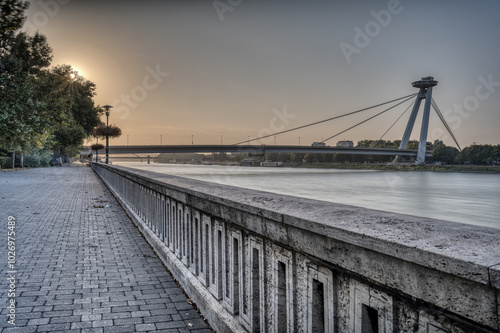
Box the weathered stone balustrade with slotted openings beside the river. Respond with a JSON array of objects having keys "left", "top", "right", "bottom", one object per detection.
[{"left": 93, "top": 164, "right": 500, "bottom": 333}]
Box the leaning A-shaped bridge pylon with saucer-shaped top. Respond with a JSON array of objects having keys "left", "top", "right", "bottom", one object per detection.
[{"left": 396, "top": 76, "right": 438, "bottom": 164}]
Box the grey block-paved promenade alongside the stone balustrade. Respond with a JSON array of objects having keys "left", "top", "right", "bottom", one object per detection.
[{"left": 0, "top": 164, "right": 211, "bottom": 333}]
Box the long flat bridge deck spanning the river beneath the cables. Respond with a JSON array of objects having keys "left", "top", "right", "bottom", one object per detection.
[{"left": 82, "top": 145, "right": 432, "bottom": 158}]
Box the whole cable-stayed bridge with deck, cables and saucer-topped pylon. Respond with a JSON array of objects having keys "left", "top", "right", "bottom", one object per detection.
[{"left": 82, "top": 76, "right": 460, "bottom": 164}]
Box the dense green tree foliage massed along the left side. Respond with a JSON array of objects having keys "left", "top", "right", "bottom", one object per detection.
[{"left": 0, "top": 0, "right": 106, "bottom": 165}]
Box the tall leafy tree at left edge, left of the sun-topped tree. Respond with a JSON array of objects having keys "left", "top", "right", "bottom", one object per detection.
[{"left": 0, "top": 33, "right": 58, "bottom": 164}]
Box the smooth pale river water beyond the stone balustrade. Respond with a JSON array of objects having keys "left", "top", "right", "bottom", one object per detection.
[{"left": 114, "top": 163, "right": 500, "bottom": 229}]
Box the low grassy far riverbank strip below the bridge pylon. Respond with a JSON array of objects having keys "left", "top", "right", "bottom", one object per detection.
[{"left": 285, "top": 163, "right": 500, "bottom": 173}]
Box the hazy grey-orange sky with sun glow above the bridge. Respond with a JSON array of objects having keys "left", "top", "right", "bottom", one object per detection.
[{"left": 25, "top": 0, "right": 500, "bottom": 146}]
